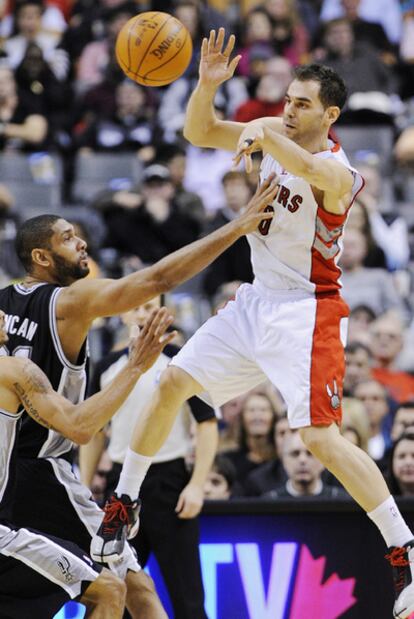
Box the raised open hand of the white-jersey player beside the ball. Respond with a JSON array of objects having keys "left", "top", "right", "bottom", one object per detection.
[{"left": 200, "top": 28, "right": 241, "bottom": 88}]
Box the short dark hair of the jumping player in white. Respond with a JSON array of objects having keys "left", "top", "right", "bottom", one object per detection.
[{"left": 293, "top": 64, "right": 348, "bottom": 110}]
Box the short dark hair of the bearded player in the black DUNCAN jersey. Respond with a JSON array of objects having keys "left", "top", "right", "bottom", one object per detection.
[{"left": 15, "top": 215, "right": 62, "bottom": 273}]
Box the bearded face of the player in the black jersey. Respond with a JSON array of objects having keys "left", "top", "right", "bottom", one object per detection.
[{"left": 50, "top": 219, "right": 89, "bottom": 286}]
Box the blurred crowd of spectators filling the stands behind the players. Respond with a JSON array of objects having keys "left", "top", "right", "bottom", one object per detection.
[{"left": 0, "top": 0, "right": 414, "bottom": 501}]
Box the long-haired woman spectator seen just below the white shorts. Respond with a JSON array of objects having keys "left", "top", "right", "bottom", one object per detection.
[{"left": 224, "top": 393, "right": 275, "bottom": 485}]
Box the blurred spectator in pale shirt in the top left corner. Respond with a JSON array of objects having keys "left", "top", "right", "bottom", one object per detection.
[{"left": 4, "top": 0, "right": 69, "bottom": 81}]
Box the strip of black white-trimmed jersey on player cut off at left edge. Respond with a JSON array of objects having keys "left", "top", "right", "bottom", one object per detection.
[{"left": 0, "top": 408, "right": 23, "bottom": 521}]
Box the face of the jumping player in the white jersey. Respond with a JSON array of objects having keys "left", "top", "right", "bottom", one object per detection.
[{"left": 283, "top": 80, "right": 330, "bottom": 143}]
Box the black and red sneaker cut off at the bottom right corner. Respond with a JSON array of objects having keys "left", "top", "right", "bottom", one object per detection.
[{"left": 385, "top": 539, "right": 414, "bottom": 619}]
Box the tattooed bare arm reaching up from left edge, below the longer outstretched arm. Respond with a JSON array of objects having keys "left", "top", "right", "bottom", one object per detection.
[{"left": 0, "top": 308, "right": 176, "bottom": 444}]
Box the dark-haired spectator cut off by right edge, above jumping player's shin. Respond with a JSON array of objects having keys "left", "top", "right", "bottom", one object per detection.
[{"left": 388, "top": 432, "right": 414, "bottom": 497}]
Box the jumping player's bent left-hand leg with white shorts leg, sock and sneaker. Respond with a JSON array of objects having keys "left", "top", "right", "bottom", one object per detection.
[{"left": 91, "top": 290, "right": 265, "bottom": 562}]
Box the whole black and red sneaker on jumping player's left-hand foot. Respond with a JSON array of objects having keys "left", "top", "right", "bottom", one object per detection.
[{"left": 91, "top": 493, "right": 141, "bottom": 563}]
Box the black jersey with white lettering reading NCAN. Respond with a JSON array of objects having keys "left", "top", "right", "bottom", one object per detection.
[{"left": 0, "top": 283, "right": 87, "bottom": 458}]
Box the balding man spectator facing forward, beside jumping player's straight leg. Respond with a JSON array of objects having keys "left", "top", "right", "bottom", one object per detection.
[{"left": 263, "top": 431, "right": 348, "bottom": 499}]
